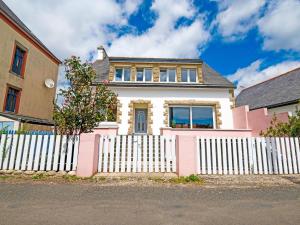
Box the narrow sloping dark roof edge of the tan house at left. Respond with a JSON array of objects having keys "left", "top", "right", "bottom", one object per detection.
[{"left": 0, "top": 0, "right": 61, "bottom": 63}]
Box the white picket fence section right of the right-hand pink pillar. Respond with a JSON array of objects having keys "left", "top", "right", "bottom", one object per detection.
[{"left": 197, "top": 137, "right": 300, "bottom": 174}]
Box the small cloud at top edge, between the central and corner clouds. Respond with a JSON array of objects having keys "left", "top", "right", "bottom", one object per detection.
[{"left": 215, "top": 0, "right": 265, "bottom": 40}]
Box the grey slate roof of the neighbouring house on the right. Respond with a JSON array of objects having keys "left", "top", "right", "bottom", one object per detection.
[{"left": 236, "top": 67, "right": 300, "bottom": 109}]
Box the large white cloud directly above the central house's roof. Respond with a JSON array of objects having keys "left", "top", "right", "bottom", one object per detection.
[{"left": 108, "top": 0, "right": 210, "bottom": 57}]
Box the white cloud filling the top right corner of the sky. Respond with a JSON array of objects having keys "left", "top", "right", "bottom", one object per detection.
[{"left": 258, "top": 0, "right": 300, "bottom": 51}]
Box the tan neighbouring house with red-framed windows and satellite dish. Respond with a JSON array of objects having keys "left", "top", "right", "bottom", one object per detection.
[{"left": 0, "top": 0, "right": 61, "bottom": 130}]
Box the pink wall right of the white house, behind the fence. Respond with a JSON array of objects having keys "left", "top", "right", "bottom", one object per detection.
[{"left": 233, "top": 106, "right": 289, "bottom": 136}]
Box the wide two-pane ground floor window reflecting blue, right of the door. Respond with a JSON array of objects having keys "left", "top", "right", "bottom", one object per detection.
[{"left": 169, "top": 106, "right": 214, "bottom": 128}]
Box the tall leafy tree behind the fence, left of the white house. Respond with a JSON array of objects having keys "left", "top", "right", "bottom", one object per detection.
[{"left": 53, "top": 56, "right": 117, "bottom": 135}]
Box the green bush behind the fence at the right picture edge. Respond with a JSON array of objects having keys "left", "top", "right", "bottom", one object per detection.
[{"left": 261, "top": 110, "right": 300, "bottom": 137}]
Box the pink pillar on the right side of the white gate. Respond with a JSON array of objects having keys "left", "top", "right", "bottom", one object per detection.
[{"left": 176, "top": 135, "right": 197, "bottom": 176}]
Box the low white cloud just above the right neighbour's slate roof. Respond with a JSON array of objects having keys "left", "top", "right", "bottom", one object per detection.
[{"left": 227, "top": 60, "right": 300, "bottom": 92}]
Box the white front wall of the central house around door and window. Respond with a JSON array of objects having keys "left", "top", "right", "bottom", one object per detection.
[{"left": 111, "top": 87, "right": 233, "bottom": 135}]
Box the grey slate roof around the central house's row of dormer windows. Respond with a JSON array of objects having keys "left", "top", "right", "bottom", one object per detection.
[{"left": 93, "top": 56, "right": 234, "bottom": 88}]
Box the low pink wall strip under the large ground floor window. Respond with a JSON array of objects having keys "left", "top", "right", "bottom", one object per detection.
[{"left": 161, "top": 128, "right": 252, "bottom": 137}]
